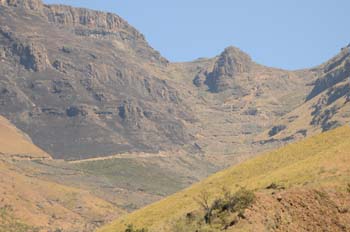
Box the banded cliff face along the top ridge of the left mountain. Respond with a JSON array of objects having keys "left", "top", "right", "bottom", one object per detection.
[{"left": 44, "top": 5, "right": 168, "bottom": 64}]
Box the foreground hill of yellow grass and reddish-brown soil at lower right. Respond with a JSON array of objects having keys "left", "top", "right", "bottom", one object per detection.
[{"left": 98, "top": 126, "right": 350, "bottom": 232}]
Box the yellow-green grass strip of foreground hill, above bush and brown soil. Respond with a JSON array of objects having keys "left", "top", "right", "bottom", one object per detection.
[{"left": 99, "top": 126, "right": 350, "bottom": 232}]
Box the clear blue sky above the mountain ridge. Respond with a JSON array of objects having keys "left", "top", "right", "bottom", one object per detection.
[{"left": 44, "top": 0, "right": 350, "bottom": 69}]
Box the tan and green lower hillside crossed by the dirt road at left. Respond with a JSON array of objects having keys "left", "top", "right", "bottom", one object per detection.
[{"left": 0, "top": 113, "right": 216, "bottom": 232}]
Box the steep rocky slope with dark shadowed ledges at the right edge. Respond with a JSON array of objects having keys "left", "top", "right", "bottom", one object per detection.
[{"left": 260, "top": 46, "right": 350, "bottom": 145}]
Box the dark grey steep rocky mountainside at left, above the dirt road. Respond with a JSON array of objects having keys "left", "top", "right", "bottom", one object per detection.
[{"left": 0, "top": 0, "right": 193, "bottom": 159}]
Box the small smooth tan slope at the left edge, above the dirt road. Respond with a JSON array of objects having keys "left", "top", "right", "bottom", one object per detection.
[{"left": 0, "top": 116, "right": 50, "bottom": 158}]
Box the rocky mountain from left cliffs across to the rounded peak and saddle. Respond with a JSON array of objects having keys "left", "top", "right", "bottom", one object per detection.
[{"left": 0, "top": 0, "right": 316, "bottom": 163}]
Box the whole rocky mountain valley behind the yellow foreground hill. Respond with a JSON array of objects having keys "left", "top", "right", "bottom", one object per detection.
[{"left": 0, "top": 0, "right": 350, "bottom": 232}]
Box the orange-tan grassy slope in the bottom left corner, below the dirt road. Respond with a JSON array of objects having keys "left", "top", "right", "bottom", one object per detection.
[{"left": 0, "top": 160, "right": 123, "bottom": 232}]
